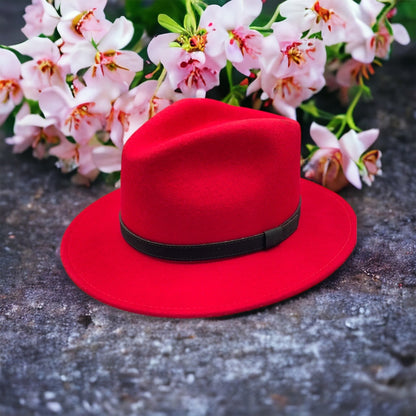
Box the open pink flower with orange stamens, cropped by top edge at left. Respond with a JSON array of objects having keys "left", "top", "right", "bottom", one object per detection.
[{"left": 58, "top": 0, "right": 111, "bottom": 44}]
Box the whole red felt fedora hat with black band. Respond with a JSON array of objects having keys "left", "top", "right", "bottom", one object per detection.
[{"left": 61, "top": 99, "right": 356, "bottom": 318}]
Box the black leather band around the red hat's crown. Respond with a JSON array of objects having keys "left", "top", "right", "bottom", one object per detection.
[{"left": 120, "top": 202, "right": 301, "bottom": 261}]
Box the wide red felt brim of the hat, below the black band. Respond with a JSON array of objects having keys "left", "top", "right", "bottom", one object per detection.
[{"left": 61, "top": 179, "right": 357, "bottom": 318}]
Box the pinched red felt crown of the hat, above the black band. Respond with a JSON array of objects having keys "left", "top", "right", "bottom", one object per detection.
[{"left": 121, "top": 99, "right": 300, "bottom": 244}]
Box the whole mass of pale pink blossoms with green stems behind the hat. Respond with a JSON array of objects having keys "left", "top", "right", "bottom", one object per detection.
[{"left": 0, "top": 0, "right": 410, "bottom": 190}]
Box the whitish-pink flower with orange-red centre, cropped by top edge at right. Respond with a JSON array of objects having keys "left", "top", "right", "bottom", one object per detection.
[{"left": 280, "top": 0, "right": 358, "bottom": 45}]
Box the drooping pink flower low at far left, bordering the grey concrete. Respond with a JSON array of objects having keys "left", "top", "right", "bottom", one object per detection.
[{"left": 6, "top": 103, "right": 64, "bottom": 159}]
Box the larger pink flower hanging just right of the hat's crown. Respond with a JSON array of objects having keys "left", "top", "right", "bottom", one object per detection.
[{"left": 304, "top": 123, "right": 379, "bottom": 189}]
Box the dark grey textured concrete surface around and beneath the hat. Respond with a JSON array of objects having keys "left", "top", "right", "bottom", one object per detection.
[{"left": 0, "top": 0, "right": 416, "bottom": 416}]
